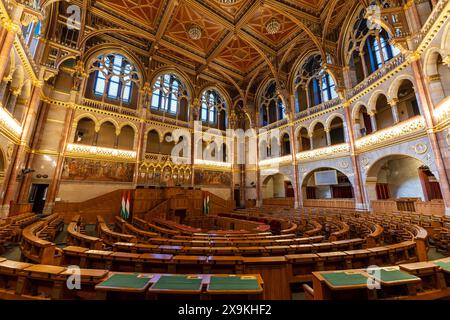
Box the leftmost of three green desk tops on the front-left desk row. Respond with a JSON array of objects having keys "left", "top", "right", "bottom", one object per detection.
[{"left": 95, "top": 273, "right": 153, "bottom": 293}]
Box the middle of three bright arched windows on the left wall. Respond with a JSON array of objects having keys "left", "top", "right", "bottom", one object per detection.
[{"left": 151, "top": 74, "right": 187, "bottom": 115}]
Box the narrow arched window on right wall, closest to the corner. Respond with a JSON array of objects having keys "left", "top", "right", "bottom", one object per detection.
[{"left": 260, "top": 80, "right": 286, "bottom": 126}]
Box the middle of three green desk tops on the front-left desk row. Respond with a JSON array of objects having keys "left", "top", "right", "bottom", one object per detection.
[{"left": 149, "top": 275, "right": 205, "bottom": 293}]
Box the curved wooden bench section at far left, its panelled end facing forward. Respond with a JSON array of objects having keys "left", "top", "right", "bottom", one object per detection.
[{"left": 20, "top": 214, "right": 62, "bottom": 265}]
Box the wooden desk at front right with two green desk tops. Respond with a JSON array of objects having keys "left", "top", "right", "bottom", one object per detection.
[{"left": 303, "top": 258, "right": 450, "bottom": 300}]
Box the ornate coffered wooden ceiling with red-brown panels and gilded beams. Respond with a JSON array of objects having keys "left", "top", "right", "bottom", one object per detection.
[{"left": 50, "top": 0, "right": 367, "bottom": 94}]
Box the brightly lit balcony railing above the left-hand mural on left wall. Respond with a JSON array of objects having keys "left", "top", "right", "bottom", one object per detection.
[{"left": 67, "top": 143, "right": 136, "bottom": 160}]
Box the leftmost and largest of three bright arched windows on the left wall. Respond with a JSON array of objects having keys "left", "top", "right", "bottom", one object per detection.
[{"left": 94, "top": 54, "right": 137, "bottom": 103}]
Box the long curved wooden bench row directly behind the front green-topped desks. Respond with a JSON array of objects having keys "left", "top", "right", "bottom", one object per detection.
[{"left": 62, "top": 241, "right": 417, "bottom": 299}]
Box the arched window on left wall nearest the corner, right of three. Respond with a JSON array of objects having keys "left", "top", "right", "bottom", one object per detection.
[{"left": 200, "top": 89, "right": 228, "bottom": 130}]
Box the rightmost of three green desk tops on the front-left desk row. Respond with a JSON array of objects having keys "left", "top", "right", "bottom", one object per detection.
[{"left": 206, "top": 275, "right": 263, "bottom": 294}]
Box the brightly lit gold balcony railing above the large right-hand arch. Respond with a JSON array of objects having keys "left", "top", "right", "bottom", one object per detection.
[{"left": 355, "top": 116, "right": 425, "bottom": 149}]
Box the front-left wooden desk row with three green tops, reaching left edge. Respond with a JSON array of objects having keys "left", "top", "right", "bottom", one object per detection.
[{"left": 0, "top": 258, "right": 264, "bottom": 300}]
